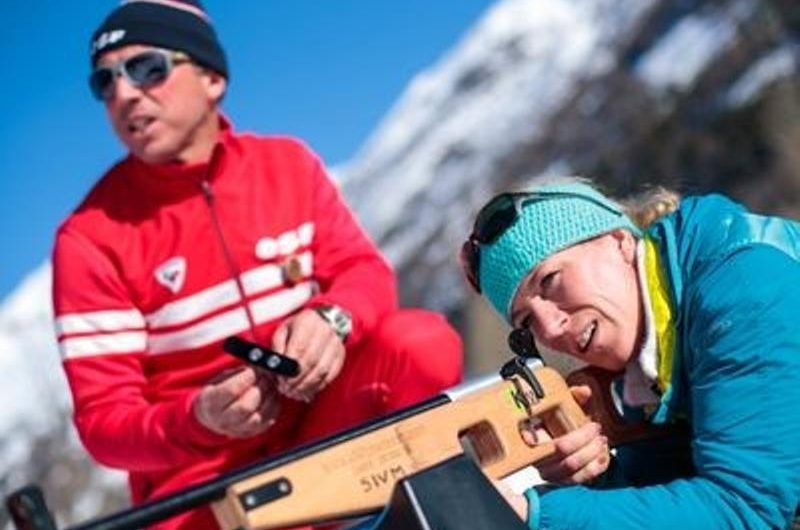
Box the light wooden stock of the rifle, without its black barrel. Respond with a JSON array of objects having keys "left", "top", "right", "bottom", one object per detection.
[{"left": 212, "top": 368, "right": 589, "bottom": 530}]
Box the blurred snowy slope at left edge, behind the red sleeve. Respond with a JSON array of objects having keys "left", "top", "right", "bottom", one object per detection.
[{"left": 0, "top": 263, "right": 125, "bottom": 527}]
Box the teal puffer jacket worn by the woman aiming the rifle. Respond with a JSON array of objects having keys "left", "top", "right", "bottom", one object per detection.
[{"left": 527, "top": 195, "right": 800, "bottom": 530}]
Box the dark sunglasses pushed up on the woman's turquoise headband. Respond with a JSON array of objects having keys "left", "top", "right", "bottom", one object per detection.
[{"left": 459, "top": 191, "right": 623, "bottom": 294}]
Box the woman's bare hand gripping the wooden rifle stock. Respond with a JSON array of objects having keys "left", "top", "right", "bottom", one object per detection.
[{"left": 522, "top": 386, "right": 610, "bottom": 484}]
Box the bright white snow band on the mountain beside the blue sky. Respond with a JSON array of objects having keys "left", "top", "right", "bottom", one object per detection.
[{"left": 342, "top": 0, "right": 654, "bottom": 239}]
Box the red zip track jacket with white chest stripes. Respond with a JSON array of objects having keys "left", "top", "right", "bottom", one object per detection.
[{"left": 53, "top": 118, "right": 397, "bottom": 508}]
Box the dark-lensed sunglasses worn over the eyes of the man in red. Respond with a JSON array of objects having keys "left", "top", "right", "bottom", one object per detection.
[{"left": 89, "top": 49, "right": 191, "bottom": 101}]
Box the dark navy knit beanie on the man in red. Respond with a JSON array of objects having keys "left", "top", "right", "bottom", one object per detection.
[{"left": 91, "top": 0, "right": 228, "bottom": 78}]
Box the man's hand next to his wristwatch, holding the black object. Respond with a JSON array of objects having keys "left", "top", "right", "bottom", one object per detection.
[{"left": 272, "top": 309, "right": 345, "bottom": 401}]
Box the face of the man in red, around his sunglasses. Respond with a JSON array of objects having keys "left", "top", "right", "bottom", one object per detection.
[{"left": 97, "top": 45, "right": 225, "bottom": 164}]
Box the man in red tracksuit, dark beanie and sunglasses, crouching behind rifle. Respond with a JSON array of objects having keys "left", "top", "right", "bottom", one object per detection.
[{"left": 53, "top": 0, "right": 462, "bottom": 529}]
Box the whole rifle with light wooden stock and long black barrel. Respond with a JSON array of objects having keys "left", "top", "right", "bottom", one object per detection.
[{"left": 7, "top": 358, "right": 664, "bottom": 530}]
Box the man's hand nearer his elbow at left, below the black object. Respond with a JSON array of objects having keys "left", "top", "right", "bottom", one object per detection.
[{"left": 192, "top": 367, "right": 280, "bottom": 438}]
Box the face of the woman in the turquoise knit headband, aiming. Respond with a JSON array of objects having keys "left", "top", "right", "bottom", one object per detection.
[{"left": 511, "top": 230, "right": 642, "bottom": 370}]
